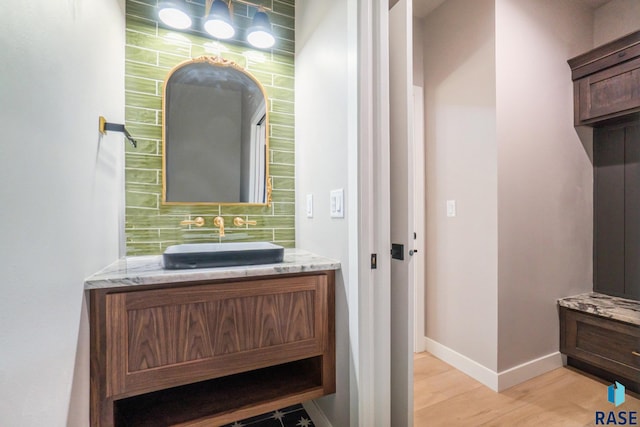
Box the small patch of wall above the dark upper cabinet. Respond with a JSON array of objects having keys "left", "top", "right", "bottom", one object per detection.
[{"left": 593, "top": 0, "right": 640, "bottom": 47}]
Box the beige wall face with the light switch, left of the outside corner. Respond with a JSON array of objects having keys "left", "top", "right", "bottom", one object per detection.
[{"left": 422, "top": 0, "right": 498, "bottom": 371}]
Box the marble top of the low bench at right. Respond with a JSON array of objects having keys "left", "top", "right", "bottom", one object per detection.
[{"left": 558, "top": 292, "right": 640, "bottom": 326}]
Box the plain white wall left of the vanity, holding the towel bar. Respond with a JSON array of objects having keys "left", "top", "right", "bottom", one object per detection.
[{"left": 0, "top": 0, "right": 124, "bottom": 427}]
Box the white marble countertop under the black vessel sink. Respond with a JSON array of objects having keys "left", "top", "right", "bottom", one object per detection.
[{"left": 84, "top": 249, "right": 340, "bottom": 289}]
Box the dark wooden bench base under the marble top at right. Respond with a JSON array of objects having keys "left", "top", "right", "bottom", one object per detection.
[{"left": 560, "top": 307, "right": 640, "bottom": 392}]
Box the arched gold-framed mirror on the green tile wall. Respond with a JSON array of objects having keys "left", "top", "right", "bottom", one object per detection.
[{"left": 163, "top": 56, "right": 268, "bottom": 204}]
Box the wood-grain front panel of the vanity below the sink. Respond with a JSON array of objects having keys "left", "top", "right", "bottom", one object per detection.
[{"left": 106, "top": 275, "right": 328, "bottom": 397}]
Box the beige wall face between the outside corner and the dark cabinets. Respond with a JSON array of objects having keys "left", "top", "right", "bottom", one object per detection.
[{"left": 496, "top": 0, "right": 593, "bottom": 371}]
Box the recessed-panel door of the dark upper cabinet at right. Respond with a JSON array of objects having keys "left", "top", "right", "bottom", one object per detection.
[{"left": 575, "top": 58, "right": 640, "bottom": 124}]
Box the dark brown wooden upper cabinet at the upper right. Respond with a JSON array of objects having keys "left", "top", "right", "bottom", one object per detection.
[{"left": 567, "top": 31, "right": 640, "bottom": 126}]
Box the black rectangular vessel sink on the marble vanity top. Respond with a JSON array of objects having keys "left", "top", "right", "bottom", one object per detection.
[{"left": 162, "top": 242, "right": 284, "bottom": 270}]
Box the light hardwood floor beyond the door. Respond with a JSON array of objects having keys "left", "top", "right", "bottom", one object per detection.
[{"left": 414, "top": 353, "right": 640, "bottom": 427}]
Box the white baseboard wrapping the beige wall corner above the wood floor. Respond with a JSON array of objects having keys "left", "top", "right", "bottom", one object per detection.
[{"left": 425, "top": 337, "right": 563, "bottom": 392}]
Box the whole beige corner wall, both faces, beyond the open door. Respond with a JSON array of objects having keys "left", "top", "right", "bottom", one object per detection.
[{"left": 422, "top": 0, "right": 593, "bottom": 373}]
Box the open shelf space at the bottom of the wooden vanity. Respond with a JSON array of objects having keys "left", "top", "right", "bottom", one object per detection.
[{"left": 114, "top": 357, "right": 325, "bottom": 427}]
